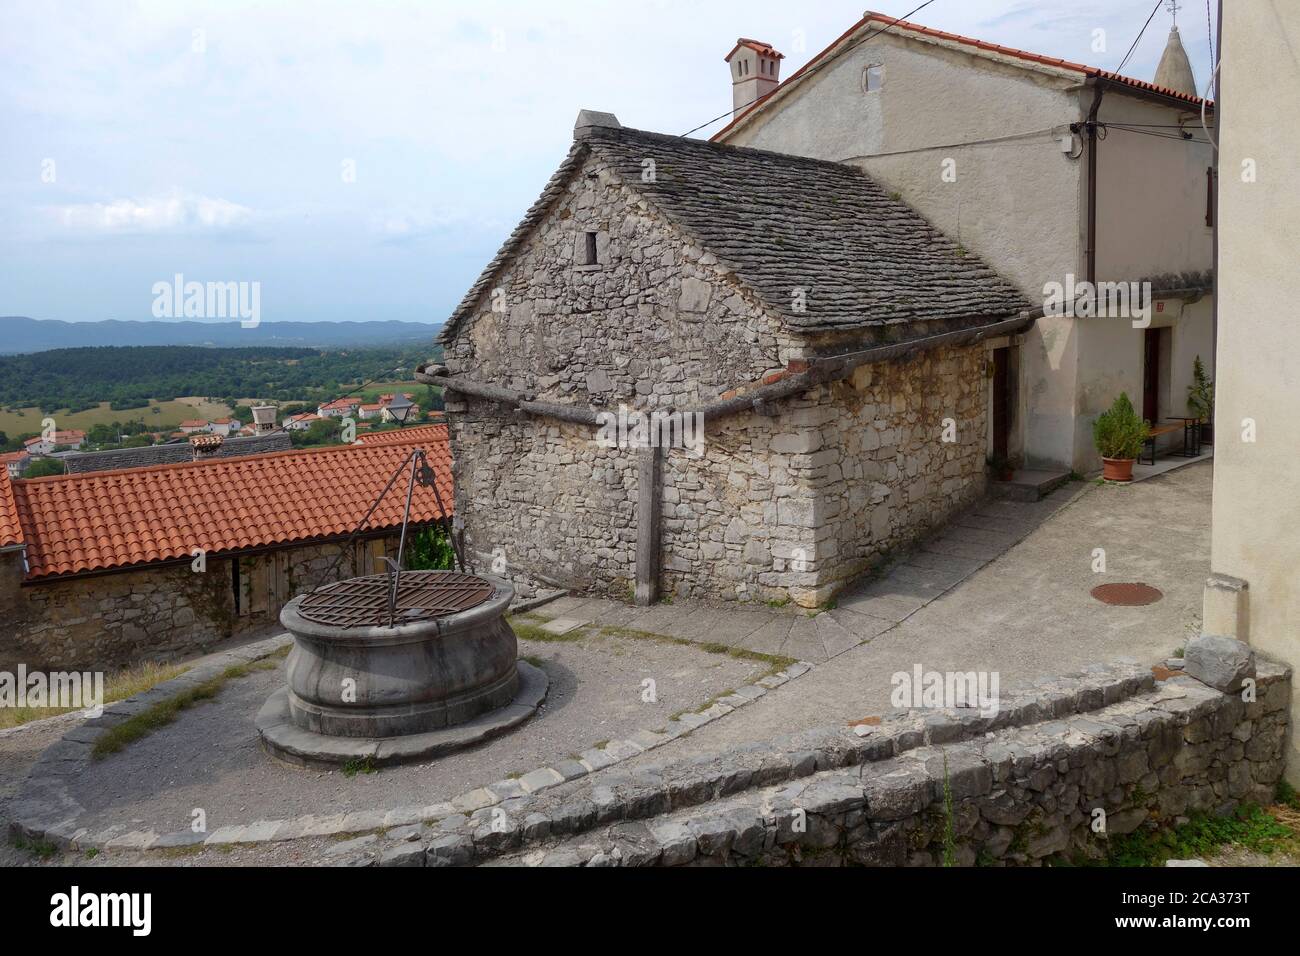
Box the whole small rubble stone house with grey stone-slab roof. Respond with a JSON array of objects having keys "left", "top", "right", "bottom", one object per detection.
[{"left": 417, "top": 112, "right": 1034, "bottom": 606}]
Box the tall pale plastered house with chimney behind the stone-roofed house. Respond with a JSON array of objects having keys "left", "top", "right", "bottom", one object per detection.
[{"left": 714, "top": 13, "right": 1216, "bottom": 473}]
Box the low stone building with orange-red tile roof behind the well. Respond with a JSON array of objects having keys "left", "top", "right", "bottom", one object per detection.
[{"left": 0, "top": 425, "right": 452, "bottom": 669}]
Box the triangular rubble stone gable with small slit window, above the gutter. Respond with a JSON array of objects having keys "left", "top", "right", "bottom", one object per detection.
[{"left": 445, "top": 149, "right": 802, "bottom": 407}]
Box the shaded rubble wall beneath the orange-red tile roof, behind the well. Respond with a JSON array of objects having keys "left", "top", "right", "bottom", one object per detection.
[{"left": 0, "top": 538, "right": 395, "bottom": 670}]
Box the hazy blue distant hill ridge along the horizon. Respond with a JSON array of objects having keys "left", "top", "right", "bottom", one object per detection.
[{"left": 0, "top": 316, "right": 442, "bottom": 355}]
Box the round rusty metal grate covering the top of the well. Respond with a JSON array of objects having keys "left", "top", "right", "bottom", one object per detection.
[{"left": 298, "top": 571, "right": 493, "bottom": 630}]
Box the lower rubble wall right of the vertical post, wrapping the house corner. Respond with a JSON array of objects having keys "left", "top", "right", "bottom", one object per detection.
[{"left": 663, "top": 346, "right": 987, "bottom": 607}]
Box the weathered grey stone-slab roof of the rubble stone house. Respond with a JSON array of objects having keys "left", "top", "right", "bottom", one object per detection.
[{"left": 441, "top": 126, "right": 1028, "bottom": 342}]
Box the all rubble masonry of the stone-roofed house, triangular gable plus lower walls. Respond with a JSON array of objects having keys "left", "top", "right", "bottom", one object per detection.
[{"left": 446, "top": 151, "right": 987, "bottom": 607}]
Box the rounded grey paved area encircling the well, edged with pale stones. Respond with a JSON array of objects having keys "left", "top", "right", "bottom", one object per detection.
[{"left": 8, "top": 629, "right": 811, "bottom": 860}]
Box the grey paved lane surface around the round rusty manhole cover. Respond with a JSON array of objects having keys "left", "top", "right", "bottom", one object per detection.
[{"left": 608, "top": 463, "right": 1213, "bottom": 769}]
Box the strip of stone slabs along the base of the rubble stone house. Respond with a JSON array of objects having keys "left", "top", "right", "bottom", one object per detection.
[{"left": 532, "top": 483, "right": 1092, "bottom": 663}]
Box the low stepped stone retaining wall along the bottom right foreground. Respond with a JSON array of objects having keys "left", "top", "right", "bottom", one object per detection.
[{"left": 366, "top": 661, "right": 1292, "bottom": 866}]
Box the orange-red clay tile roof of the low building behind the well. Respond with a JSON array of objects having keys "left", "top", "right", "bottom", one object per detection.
[{"left": 8, "top": 428, "right": 452, "bottom": 580}]
